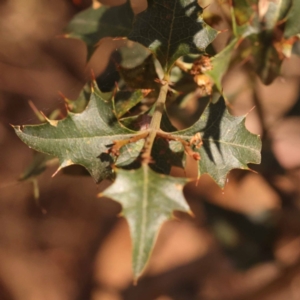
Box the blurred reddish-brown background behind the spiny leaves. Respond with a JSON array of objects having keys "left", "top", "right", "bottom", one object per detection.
[{"left": 0, "top": 0, "right": 300, "bottom": 300}]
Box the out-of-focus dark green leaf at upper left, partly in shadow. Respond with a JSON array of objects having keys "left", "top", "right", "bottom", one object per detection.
[{"left": 66, "top": 1, "right": 134, "bottom": 59}]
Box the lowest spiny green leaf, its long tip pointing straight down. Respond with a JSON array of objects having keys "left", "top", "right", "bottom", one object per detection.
[{"left": 102, "top": 165, "right": 189, "bottom": 279}]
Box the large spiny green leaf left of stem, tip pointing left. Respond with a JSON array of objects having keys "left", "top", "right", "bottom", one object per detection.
[{"left": 15, "top": 86, "right": 142, "bottom": 182}]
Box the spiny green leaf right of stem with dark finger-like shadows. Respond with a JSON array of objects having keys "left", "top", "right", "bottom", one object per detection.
[{"left": 173, "top": 98, "right": 261, "bottom": 187}]
